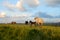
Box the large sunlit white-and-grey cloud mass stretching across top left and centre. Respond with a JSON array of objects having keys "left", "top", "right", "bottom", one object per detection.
[{"left": 3, "top": 0, "right": 39, "bottom": 11}]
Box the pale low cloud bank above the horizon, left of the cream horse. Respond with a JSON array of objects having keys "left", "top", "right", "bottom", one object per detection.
[{"left": 0, "top": 13, "right": 33, "bottom": 23}]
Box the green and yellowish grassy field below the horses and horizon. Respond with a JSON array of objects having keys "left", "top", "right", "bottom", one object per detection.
[{"left": 0, "top": 24, "right": 60, "bottom": 40}]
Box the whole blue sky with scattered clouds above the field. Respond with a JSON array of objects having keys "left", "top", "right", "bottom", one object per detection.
[{"left": 0, "top": 0, "right": 60, "bottom": 23}]
